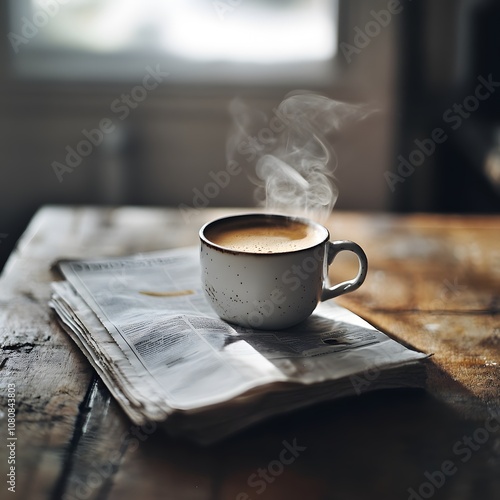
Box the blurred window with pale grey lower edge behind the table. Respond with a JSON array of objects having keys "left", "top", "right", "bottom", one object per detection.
[{"left": 9, "top": 0, "right": 337, "bottom": 83}]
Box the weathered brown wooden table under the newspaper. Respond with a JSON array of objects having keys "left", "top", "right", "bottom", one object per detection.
[{"left": 0, "top": 207, "right": 500, "bottom": 500}]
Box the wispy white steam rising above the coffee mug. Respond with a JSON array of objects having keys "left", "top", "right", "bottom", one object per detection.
[{"left": 227, "top": 91, "right": 373, "bottom": 220}]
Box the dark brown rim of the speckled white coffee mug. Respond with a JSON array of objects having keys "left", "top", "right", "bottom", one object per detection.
[{"left": 198, "top": 212, "right": 330, "bottom": 257}]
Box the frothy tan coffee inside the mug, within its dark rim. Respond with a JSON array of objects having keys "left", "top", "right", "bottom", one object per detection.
[{"left": 207, "top": 219, "right": 325, "bottom": 253}]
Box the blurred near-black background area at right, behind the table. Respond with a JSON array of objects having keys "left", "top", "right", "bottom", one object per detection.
[{"left": 393, "top": 1, "right": 500, "bottom": 213}]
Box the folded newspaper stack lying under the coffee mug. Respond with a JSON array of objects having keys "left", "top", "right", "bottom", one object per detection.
[{"left": 50, "top": 248, "right": 427, "bottom": 444}]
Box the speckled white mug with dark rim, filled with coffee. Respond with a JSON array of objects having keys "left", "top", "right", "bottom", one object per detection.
[{"left": 199, "top": 213, "right": 368, "bottom": 330}]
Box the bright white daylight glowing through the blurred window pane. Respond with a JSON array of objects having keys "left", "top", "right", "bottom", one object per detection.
[{"left": 31, "top": 0, "right": 337, "bottom": 64}]
